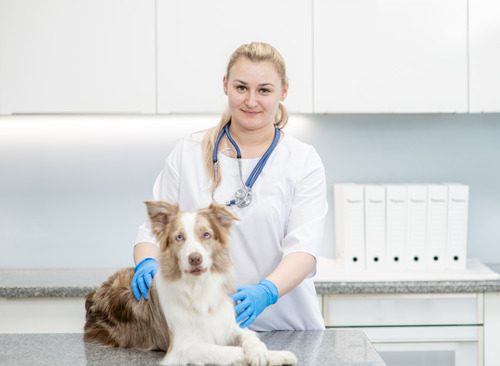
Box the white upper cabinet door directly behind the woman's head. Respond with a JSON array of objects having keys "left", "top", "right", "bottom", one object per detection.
[{"left": 157, "top": 0, "right": 312, "bottom": 113}]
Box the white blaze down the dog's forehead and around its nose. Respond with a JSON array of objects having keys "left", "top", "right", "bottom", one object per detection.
[{"left": 179, "top": 212, "right": 212, "bottom": 270}]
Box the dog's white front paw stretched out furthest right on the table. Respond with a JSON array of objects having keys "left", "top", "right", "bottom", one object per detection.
[{"left": 236, "top": 329, "right": 297, "bottom": 366}]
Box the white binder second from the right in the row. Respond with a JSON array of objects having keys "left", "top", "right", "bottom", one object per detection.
[{"left": 426, "top": 184, "right": 448, "bottom": 270}]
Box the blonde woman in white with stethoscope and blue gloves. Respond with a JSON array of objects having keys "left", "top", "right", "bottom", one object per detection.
[{"left": 132, "top": 43, "right": 327, "bottom": 331}]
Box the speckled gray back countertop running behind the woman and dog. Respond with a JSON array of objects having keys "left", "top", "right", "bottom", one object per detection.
[{"left": 0, "top": 264, "right": 500, "bottom": 298}]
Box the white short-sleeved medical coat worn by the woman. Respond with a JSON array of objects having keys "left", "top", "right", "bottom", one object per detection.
[{"left": 136, "top": 129, "right": 328, "bottom": 331}]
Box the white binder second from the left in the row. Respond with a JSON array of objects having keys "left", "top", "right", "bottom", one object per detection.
[{"left": 365, "top": 185, "right": 387, "bottom": 271}]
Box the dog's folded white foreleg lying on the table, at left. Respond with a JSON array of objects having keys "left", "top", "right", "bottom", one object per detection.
[{"left": 160, "top": 343, "right": 246, "bottom": 366}]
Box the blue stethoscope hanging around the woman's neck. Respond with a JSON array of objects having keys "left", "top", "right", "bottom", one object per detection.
[{"left": 212, "top": 121, "right": 280, "bottom": 208}]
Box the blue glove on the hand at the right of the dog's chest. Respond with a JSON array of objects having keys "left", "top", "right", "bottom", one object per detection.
[{"left": 231, "top": 280, "right": 278, "bottom": 328}]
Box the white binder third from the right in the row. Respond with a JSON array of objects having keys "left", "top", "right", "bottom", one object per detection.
[{"left": 406, "top": 184, "right": 427, "bottom": 271}]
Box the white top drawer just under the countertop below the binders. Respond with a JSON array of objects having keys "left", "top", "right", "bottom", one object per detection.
[{"left": 322, "top": 294, "right": 483, "bottom": 327}]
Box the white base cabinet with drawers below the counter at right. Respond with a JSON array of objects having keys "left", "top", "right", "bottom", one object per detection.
[{"left": 322, "top": 293, "right": 482, "bottom": 366}]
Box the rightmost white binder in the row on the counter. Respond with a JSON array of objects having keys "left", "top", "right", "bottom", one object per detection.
[{"left": 446, "top": 184, "right": 469, "bottom": 270}]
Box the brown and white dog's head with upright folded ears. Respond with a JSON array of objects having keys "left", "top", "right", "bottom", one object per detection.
[{"left": 145, "top": 201, "right": 237, "bottom": 280}]
